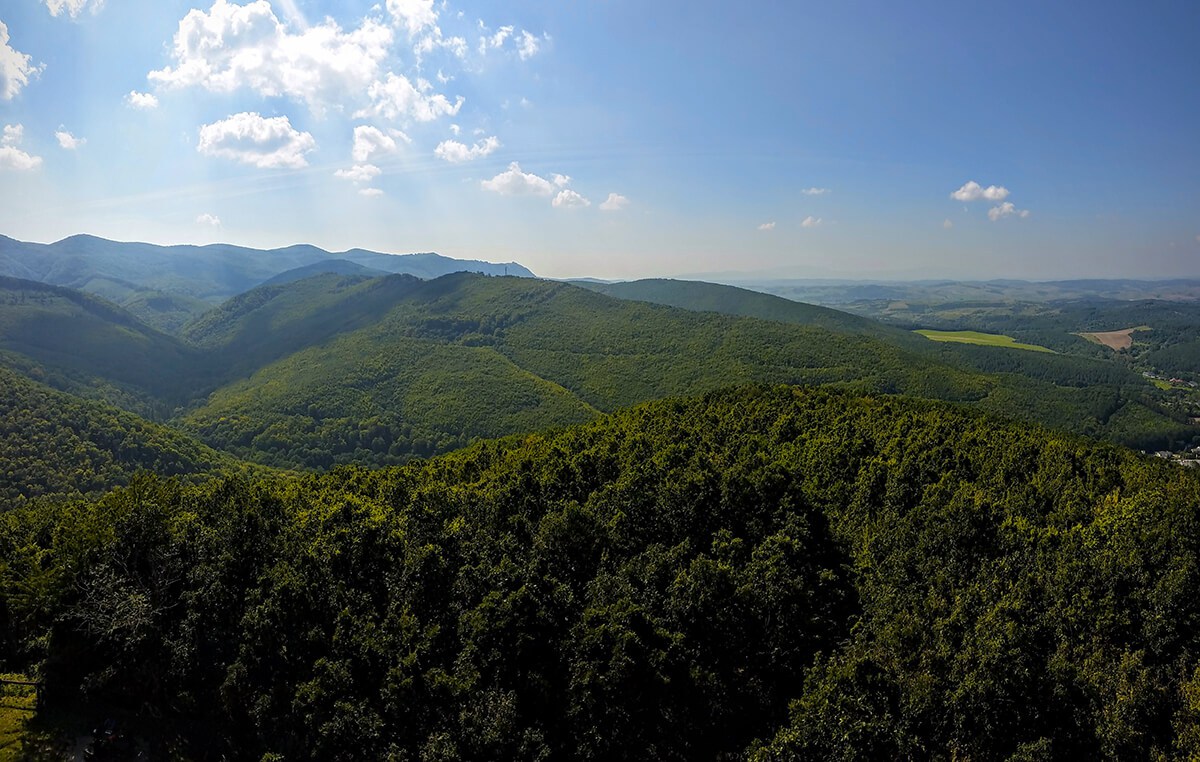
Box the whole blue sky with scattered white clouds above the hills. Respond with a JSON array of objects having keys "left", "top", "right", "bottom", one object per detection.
[{"left": 0, "top": 0, "right": 1200, "bottom": 280}]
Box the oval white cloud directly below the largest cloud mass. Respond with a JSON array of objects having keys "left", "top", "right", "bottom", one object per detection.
[{"left": 196, "top": 112, "right": 317, "bottom": 169}]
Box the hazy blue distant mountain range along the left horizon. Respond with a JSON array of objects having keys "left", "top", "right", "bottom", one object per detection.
[{"left": 0, "top": 235, "right": 534, "bottom": 329}]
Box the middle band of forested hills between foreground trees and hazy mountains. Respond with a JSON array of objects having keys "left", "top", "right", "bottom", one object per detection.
[{"left": 0, "top": 268, "right": 1196, "bottom": 468}]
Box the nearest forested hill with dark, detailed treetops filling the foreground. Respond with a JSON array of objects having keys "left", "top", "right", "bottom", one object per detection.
[{"left": 0, "top": 388, "right": 1200, "bottom": 761}]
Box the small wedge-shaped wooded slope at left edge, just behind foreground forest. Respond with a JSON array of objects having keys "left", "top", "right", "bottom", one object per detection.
[{"left": 0, "top": 367, "right": 235, "bottom": 504}]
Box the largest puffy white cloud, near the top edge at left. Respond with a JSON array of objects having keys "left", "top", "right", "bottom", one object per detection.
[{"left": 149, "top": 0, "right": 392, "bottom": 112}]
